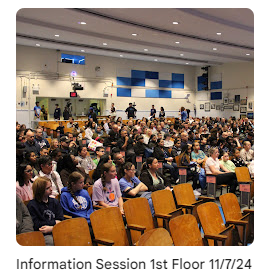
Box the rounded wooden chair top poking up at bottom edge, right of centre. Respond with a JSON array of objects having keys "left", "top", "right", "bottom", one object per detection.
[{"left": 137, "top": 228, "right": 173, "bottom": 246}]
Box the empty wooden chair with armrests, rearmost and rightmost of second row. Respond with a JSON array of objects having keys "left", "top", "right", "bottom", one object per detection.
[{"left": 173, "top": 183, "right": 215, "bottom": 223}]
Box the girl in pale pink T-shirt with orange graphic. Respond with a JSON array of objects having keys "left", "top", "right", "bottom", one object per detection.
[{"left": 92, "top": 162, "right": 124, "bottom": 215}]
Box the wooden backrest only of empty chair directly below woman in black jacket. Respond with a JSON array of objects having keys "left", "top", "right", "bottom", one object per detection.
[{"left": 151, "top": 190, "right": 176, "bottom": 227}]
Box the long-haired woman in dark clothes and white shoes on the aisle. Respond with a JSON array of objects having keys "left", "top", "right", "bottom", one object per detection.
[{"left": 179, "top": 144, "right": 201, "bottom": 196}]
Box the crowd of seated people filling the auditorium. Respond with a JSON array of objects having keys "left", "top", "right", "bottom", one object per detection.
[{"left": 16, "top": 117, "right": 254, "bottom": 245}]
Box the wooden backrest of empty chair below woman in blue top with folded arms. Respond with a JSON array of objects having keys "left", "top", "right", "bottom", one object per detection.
[{"left": 124, "top": 197, "right": 155, "bottom": 244}]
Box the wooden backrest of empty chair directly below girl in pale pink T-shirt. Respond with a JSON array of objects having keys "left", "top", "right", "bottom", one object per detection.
[{"left": 90, "top": 207, "right": 129, "bottom": 246}]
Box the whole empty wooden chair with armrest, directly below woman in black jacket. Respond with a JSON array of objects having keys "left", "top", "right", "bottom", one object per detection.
[{"left": 151, "top": 190, "right": 183, "bottom": 231}]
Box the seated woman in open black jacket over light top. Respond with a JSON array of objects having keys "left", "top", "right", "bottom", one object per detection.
[{"left": 140, "top": 157, "right": 171, "bottom": 192}]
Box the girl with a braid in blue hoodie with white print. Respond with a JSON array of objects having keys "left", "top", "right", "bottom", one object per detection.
[{"left": 60, "top": 172, "right": 94, "bottom": 225}]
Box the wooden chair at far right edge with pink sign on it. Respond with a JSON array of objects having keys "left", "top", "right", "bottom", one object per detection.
[{"left": 235, "top": 167, "right": 254, "bottom": 208}]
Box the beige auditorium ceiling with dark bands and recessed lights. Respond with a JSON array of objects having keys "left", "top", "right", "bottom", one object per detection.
[{"left": 16, "top": 8, "right": 254, "bottom": 66}]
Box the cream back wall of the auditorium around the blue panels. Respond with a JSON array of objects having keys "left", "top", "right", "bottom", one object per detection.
[{"left": 16, "top": 45, "right": 254, "bottom": 127}]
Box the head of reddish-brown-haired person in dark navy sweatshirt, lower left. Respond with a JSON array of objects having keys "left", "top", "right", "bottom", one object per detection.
[{"left": 32, "top": 177, "right": 52, "bottom": 203}]
